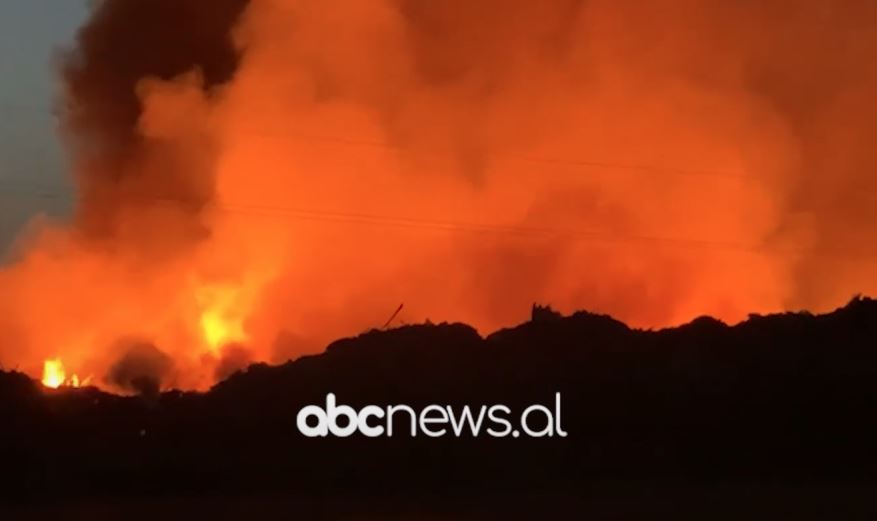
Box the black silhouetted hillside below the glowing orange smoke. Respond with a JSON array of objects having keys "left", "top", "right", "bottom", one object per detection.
[{"left": 0, "top": 299, "right": 877, "bottom": 520}]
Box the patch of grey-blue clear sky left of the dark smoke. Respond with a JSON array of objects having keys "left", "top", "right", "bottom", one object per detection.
[{"left": 0, "top": 0, "right": 87, "bottom": 252}]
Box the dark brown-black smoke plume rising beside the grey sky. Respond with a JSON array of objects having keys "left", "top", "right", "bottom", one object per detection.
[{"left": 62, "top": 0, "right": 249, "bottom": 233}]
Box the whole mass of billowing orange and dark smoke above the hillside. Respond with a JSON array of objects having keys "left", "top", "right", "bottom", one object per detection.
[{"left": 0, "top": 0, "right": 877, "bottom": 387}]
